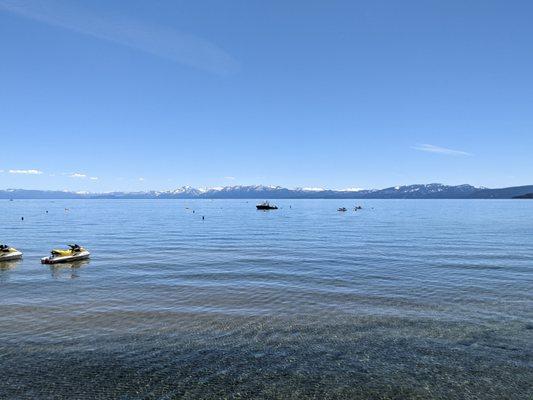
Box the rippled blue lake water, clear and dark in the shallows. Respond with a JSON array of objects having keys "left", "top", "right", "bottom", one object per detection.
[{"left": 0, "top": 200, "right": 533, "bottom": 399}]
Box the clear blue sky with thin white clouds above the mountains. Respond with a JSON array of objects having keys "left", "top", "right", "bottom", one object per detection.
[{"left": 0, "top": 0, "right": 533, "bottom": 192}]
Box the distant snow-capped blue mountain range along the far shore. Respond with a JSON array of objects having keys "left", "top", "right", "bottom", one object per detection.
[{"left": 0, "top": 183, "right": 533, "bottom": 200}]
